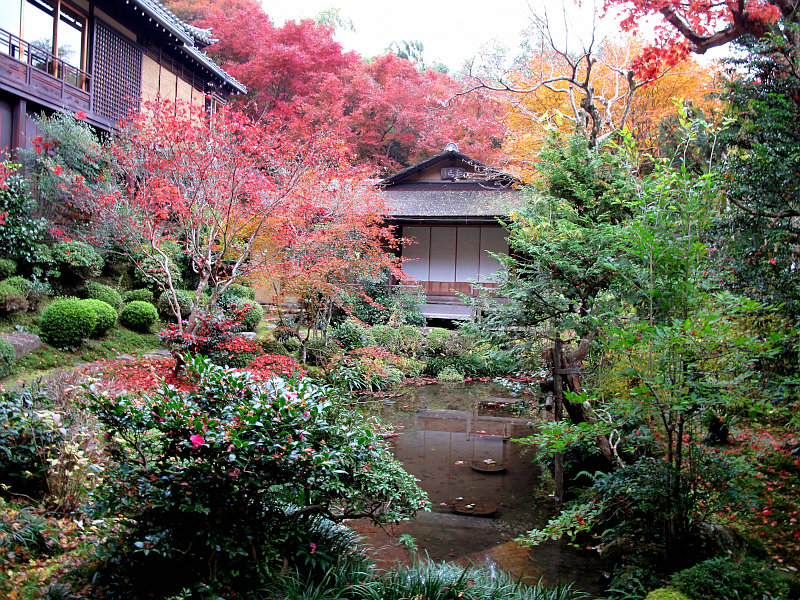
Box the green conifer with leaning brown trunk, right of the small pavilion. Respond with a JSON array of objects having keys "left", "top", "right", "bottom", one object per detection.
[{"left": 472, "top": 133, "right": 636, "bottom": 504}]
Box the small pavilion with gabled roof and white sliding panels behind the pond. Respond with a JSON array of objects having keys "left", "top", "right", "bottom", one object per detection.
[{"left": 380, "top": 143, "right": 525, "bottom": 319}]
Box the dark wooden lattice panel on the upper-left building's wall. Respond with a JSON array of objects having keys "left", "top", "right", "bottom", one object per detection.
[{"left": 92, "top": 19, "right": 142, "bottom": 123}]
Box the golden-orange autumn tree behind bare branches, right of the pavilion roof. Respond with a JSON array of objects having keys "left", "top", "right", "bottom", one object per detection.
[{"left": 503, "top": 36, "right": 718, "bottom": 172}]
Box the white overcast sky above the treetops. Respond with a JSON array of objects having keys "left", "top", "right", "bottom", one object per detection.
[{"left": 262, "top": 0, "right": 616, "bottom": 72}]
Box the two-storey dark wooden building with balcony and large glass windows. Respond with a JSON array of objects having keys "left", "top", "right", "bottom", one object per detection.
[{"left": 0, "top": 0, "right": 246, "bottom": 157}]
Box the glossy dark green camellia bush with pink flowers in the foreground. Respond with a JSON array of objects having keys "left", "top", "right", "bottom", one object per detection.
[{"left": 82, "top": 357, "right": 427, "bottom": 592}]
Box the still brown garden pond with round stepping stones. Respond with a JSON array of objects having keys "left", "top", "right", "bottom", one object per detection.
[{"left": 356, "top": 382, "right": 604, "bottom": 595}]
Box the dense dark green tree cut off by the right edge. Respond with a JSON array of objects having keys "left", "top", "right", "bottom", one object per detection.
[{"left": 717, "top": 25, "right": 800, "bottom": 322}]
